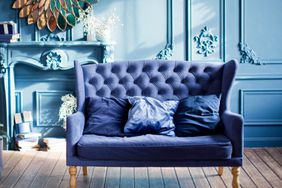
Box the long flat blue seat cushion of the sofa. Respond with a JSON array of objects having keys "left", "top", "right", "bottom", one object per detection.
[{"left": 77, "top": 134, "right": 232, "bottom": 161}]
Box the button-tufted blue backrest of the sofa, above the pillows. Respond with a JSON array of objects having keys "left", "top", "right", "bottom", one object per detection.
[{"left": 75, "top": 60, "right": 236, "bottom": 113}]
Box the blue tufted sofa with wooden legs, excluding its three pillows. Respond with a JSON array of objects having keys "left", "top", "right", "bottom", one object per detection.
[{"left": 67, "top": 60, "right": 243, "bottom": 187}]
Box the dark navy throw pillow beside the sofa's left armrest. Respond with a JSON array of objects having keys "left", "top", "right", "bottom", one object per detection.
[{"left": 83, "top": 97, "right": 131, "bottom": 136}]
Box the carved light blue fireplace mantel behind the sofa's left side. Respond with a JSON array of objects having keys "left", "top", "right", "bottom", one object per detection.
[{"left": 0, "top": 41, "right": 114, "bottom": 148}]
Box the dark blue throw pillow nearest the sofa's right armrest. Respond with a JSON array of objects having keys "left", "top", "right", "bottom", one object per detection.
[{"left": 174, "top": 95, "right": 220, "bottom": 137}]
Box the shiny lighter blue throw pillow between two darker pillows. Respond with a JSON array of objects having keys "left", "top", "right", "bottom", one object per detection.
[{"left": 124, "top": 96, "right": 178, "bottom": 136}]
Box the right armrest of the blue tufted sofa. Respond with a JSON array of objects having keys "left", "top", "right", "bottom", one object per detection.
[{"left": 221, "top": 111, "right": 244, "bottom": 157}]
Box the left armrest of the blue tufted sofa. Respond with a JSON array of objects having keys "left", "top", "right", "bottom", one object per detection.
[{"left": 66, "top": 111, "right": 85, "bottom": 160}]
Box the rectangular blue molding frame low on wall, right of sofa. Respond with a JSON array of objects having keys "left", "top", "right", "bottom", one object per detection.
[{"left": 239, "top": 89, "right": 282, "bottom": 126}]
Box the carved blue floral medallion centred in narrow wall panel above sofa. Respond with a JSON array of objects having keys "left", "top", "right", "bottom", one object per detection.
[{"left": 194, "top": 26, "right": 218, "bottom": 57}]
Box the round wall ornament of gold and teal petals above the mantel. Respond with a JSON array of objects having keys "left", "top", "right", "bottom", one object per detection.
[{"left": 12, "top": 0, "right": 98, "bottom": 32}]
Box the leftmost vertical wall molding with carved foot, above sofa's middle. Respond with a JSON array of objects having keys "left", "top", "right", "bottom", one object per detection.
[{"left": 155, "top": 0, "right": 174, "bottom": 60}]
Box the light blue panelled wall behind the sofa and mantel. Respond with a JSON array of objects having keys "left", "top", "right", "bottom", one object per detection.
[{"left": 0, "top": 0, "right": 282, "bottom": 146}]
